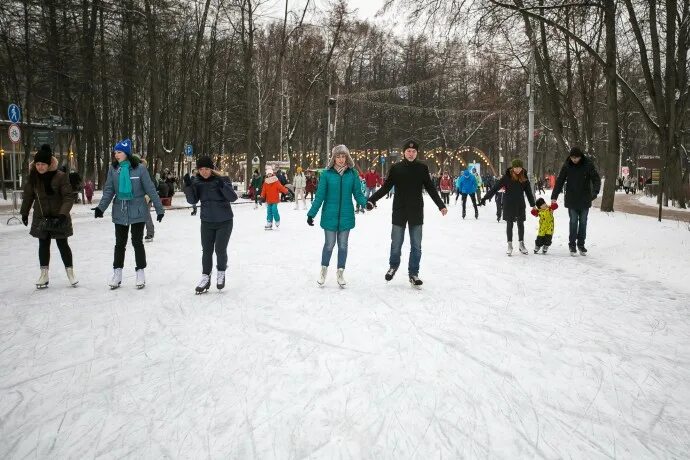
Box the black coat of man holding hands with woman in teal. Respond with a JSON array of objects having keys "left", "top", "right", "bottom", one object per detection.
[{"left": 369, "top": 159, "right": 446, "bottom": 226}]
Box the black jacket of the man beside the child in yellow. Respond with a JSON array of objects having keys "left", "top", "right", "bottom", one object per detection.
[{"left": 551, "top": 156, "right": 601, "bottom": 209}]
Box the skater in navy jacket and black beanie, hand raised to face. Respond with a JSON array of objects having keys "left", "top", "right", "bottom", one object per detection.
[{"left": 184, "top": 157, "right": 237, "bottom": 294}]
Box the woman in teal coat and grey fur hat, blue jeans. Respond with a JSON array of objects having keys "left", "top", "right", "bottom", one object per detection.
[{"left": 307, "top": 145, "right": 367, "bottom": 287}]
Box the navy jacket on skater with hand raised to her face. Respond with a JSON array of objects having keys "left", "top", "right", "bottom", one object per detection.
[{"left": 184, "top": 174, "right": 237, "bottom": 222}]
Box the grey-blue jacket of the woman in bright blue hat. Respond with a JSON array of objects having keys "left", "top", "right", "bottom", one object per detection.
[{"left": 98, "top": 155, "right": 165, "bottom": 225}]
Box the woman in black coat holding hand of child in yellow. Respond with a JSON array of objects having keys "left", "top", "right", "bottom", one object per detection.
[{"left": 479, "top": 158, "right": 534, "bottom": 255}]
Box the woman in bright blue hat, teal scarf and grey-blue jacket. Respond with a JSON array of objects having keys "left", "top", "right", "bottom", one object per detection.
[{"left": 93, "top": 139, "right": 165, "bottom": 289}]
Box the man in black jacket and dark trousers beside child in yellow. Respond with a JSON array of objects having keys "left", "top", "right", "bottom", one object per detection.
[{"left": 551, "top": 147, "right": 601, "bottom": 256}]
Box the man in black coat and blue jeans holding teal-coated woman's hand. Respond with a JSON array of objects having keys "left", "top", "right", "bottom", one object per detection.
[{"left": 367, "top": 141, "right": 448, "bottom": 288}]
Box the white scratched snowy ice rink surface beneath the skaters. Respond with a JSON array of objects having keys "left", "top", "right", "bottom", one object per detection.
[{"left": 0, "top": 192, "right": 690, "bottom": 459}]
